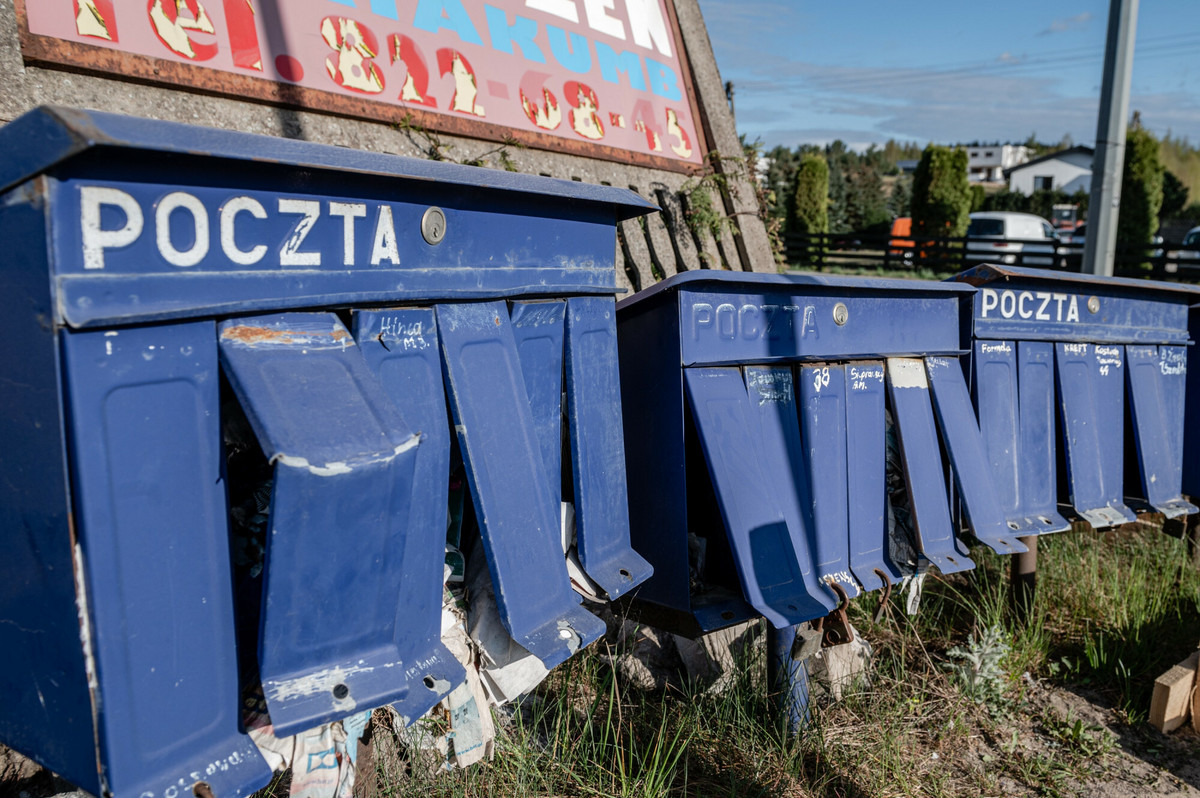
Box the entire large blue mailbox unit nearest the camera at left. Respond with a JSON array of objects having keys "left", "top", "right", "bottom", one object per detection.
[{"left": 0, "top": 108, "right": 652, "bottom": 798}]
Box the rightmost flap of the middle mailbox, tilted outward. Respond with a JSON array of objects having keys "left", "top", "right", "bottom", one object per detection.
[{"left": 925, "top": 358, "right": 1028, "bottom": 554}]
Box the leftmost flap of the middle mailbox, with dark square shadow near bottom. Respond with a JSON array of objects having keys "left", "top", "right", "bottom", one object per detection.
[{"left": 684, "top": 367, "right": 827, "bottom": 629}]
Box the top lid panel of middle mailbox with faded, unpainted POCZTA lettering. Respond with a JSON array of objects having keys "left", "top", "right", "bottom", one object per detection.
[{"left": 617, "top": 271, "right": 973, "bottom": 366}]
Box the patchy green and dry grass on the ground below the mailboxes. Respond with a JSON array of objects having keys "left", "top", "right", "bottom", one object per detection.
[{"left": 285, "top": 524, "right": 1200, "bottom": 798}]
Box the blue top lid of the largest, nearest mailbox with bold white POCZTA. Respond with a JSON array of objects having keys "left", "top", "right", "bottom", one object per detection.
[{"left": 0, "top": 108, "right": 654, "bottom": 329}]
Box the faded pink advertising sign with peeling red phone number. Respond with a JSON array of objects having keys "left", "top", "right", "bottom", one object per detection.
[{"left": 17, "top": 0, "right": 703, "bottom": 170}]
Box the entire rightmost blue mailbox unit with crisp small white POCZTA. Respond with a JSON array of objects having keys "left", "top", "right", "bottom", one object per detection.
[{"left": 954, "top": 265, "right": 1200, "bottom": 535}]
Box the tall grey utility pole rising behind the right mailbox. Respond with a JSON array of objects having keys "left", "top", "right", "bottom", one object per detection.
[{"left": 1084, "top": 0, "right": 1138, "bottom": 275}]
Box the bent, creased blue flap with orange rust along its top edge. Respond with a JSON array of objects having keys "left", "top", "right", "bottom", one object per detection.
[{"left": 220, "top": 313, "right": 425, "bottom": 736}]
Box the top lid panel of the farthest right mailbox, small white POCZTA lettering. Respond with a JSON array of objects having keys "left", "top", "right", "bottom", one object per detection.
[{"left": 949, "top": 264, "right": 1200, "bottom": 343}]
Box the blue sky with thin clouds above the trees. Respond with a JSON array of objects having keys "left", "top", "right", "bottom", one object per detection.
[{"left": 700, "top": 0, "right": 1200, "bottom": 148}]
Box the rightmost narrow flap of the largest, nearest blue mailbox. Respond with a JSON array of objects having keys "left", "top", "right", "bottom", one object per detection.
[{"left": 566, "top": 296, "right": 653, "bottom": 600}]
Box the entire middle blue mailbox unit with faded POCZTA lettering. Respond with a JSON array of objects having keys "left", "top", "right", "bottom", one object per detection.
[{"left": 617, "top": 272, "right": 1024, "bottom": 635}]
